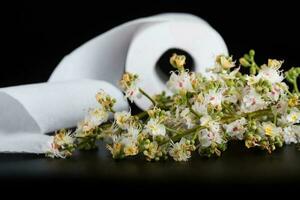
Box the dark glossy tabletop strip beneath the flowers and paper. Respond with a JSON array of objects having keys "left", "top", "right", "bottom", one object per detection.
[{"left": 0, "top": 143, "right": 300, "bottom": 184}]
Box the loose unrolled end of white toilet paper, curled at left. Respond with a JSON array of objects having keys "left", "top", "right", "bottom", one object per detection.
[{"left": 0, "top": 80, "right": 128, "bottom": 153}]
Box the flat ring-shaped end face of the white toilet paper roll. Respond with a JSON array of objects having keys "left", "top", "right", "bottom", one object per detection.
[{"left": 125, "top": 21, "right": 227, "bottom": 109}]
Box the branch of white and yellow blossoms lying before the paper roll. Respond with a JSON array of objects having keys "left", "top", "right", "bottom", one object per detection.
[{"left": 47, "top": 50, "right": 300, "bottom": 161}]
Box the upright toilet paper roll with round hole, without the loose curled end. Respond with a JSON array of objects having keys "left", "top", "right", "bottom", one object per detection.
[{"left": 49, "top": 13, "right": 228, "bottom": 109}]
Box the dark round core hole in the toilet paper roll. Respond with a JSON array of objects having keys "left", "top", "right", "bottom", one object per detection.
[{"left": 155, "top": 48, "right": 195, "bottom": 83}]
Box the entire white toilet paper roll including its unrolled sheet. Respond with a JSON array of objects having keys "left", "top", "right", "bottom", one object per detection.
[{"left": 0, "top": 13, "right": 227, "bottom": 153}]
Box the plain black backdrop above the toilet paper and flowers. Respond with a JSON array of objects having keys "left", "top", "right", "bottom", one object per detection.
[{"left": 0, "top": 0, "right": 300, "bottom": 87}]
